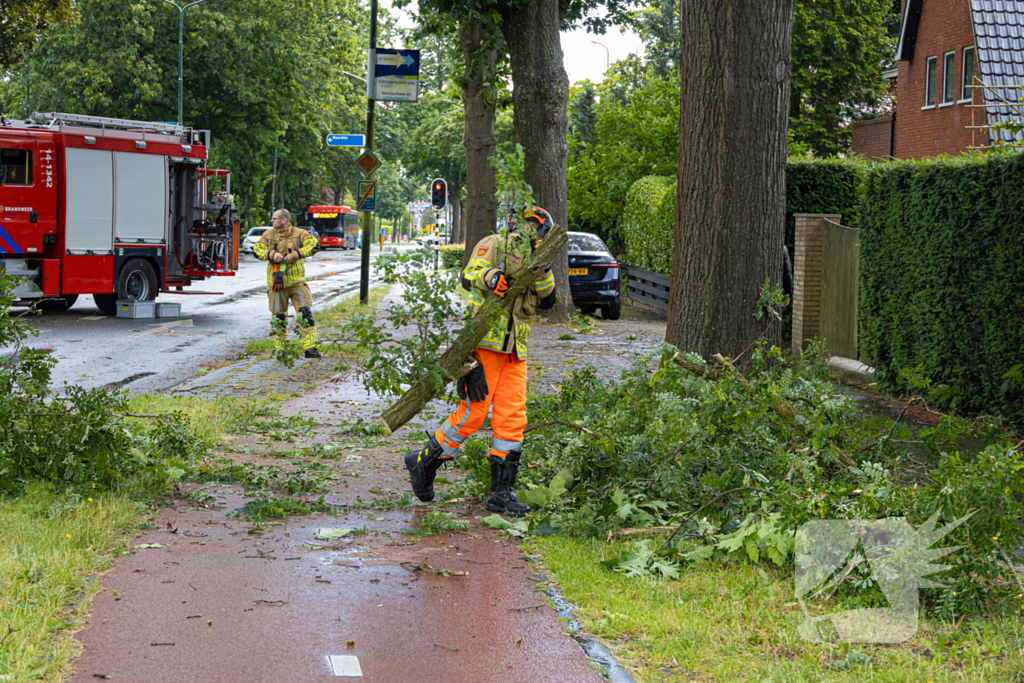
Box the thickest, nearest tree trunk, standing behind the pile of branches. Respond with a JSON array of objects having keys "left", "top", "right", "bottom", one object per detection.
[{"left": 666, "top": 0, "right": 794, "bottom": 358}]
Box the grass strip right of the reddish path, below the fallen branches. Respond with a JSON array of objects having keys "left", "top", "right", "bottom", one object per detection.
[{"left": 531, "top": 537, "right": 1024, "bottom": 683}]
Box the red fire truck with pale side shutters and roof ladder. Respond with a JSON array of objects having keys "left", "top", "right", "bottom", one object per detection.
[{"left": 0, "top": 114, "right": 239, "bottom": 315}]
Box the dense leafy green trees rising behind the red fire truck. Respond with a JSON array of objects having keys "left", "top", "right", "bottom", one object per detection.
[{"left": 0, "top": 0, "right": 426, "bottom": 225}]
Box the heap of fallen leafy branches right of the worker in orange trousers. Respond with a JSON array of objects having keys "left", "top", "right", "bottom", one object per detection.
[{"left": 524, "top": 344, "right": 1024, "bottom": 618}]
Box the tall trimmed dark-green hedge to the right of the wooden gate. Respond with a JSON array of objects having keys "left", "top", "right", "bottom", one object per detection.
[{"left": 860, "top": 154, "right": 1024, "bottom": 417}]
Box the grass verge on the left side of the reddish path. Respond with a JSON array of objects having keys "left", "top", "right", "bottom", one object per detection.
[{"left": 0, "top": 484, "right": 145, "bottom": 682}]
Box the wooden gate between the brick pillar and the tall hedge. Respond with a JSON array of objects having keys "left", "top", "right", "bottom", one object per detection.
[{"left": 819, "top": 218, "right": 860, "bottom": 358}]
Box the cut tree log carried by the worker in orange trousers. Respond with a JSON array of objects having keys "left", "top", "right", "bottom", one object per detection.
[{"left": 381, "top": 225, "right": 568, "bottom": 433}]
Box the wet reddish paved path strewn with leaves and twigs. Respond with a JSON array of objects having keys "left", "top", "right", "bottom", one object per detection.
[{"left": 71, "top": 302, "right": 664, "bottom": 683}]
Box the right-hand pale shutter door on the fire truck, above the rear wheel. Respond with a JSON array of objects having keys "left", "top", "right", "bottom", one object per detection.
[{"left": 114, "top": 152, "right": 167, "bottom": 243}]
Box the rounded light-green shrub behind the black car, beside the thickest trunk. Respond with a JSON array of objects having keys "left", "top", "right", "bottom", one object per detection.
[{"left": 622, "top": 175, "right": 676, "bottom": 275}]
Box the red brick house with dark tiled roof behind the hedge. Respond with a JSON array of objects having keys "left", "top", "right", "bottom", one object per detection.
[{"left": 852, "top": 0, "right": 1024, "bottom": 159}]
